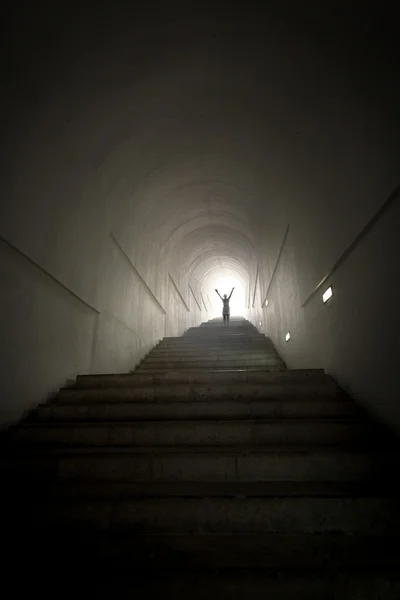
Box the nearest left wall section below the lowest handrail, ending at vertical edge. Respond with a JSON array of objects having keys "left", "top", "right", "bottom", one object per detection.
[{"left": 0, "top": 237, "right": 99, "bottom": 424}]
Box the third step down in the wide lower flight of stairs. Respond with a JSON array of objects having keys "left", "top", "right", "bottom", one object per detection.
[{"left": 34, "top": 399, "right": 357, "bottom": 422}]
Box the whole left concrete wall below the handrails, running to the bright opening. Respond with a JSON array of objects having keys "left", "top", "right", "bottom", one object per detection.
[{"left": 0, "top": 226, "right": 202, "bottom": 424}]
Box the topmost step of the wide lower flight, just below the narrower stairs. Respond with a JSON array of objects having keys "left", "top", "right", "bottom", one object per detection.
[{"left": 74, "top": 369, "right": 328, "bottom": 393}]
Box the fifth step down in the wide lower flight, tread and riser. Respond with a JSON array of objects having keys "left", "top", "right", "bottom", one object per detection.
[{"left": 0, "top": 446, "right": 400, "bottom": 482}]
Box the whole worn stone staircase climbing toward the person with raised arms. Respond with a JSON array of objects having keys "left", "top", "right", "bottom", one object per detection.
[{"left": 1, "top": 319, "right": 400, "bottom": 600}]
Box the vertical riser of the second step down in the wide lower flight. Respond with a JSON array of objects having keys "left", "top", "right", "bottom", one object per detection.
[{"left": 58, "top": 376, "right": 338, "bottom": 402}]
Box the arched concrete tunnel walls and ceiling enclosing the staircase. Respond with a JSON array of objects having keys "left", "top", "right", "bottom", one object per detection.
[{"left": 0, "top": 2, "right": 400, "bottom": 429}]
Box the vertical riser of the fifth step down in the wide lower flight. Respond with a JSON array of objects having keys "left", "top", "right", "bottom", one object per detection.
[{"left": 56, "top": 451, "right": 384, "bottom": 482}]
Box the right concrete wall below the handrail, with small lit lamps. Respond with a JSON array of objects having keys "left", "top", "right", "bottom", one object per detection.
[{"left": 252, "top": 190, "right": 400, "bottom": 430}]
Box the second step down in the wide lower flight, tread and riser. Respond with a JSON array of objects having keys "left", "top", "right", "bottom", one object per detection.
[{"left": 54, "top": 380, "right": 339, "bottom": 403}]
